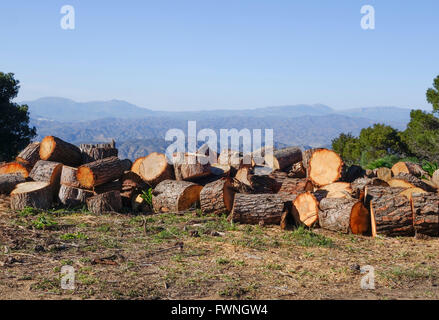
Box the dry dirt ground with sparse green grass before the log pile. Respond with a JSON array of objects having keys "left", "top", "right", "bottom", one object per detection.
[{"left": 0, "top": 198, "right": 439, "bottom": 300}]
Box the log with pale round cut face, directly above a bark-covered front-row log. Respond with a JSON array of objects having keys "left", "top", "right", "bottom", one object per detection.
[{"left": 139, "top": 152, "right": 175, "bottom": 187}]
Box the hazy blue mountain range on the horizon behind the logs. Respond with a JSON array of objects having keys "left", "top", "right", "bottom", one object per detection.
[{"left": 21, "top": 98, "right": 418, "bottom": 159}]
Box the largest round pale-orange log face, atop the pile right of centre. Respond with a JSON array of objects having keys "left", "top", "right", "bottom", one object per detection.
[{"left": 308, "top": 149, "right": 343, "bottom": 186}]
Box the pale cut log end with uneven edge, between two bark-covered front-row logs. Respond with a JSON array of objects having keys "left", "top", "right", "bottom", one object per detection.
[{"left": 292, "top": 192, "right": 319, "bottom": 227}]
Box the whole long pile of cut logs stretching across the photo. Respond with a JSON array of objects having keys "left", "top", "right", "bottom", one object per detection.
[{"left": 0, "top": 136, "right": 439, "bottom": 236}]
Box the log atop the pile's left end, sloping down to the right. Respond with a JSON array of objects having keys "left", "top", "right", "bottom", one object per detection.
[{"left": 40, "top": 136, "right": 82, "bottom": 167}]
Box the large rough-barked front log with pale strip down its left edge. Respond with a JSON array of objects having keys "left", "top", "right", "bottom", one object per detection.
[{"left": 366, "top": 187, "right": 415, "bottom": 237}]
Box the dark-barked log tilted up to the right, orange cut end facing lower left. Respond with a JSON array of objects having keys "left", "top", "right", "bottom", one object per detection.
[{"left": 76, "top": 157, "right": 123, "bottom": 189}]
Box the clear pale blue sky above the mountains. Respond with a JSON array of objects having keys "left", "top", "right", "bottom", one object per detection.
[{"left": 0, "top": 0, "right": 439, "bottom": 110}]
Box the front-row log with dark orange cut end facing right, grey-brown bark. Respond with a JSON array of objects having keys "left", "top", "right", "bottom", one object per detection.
[{"left": 319, "top": 198, "right": 370, "bottom": 235}]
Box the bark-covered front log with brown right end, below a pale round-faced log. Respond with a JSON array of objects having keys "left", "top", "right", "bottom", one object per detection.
[{"left": 152, "top": 180, "right": 203, "bottom": 212}]
